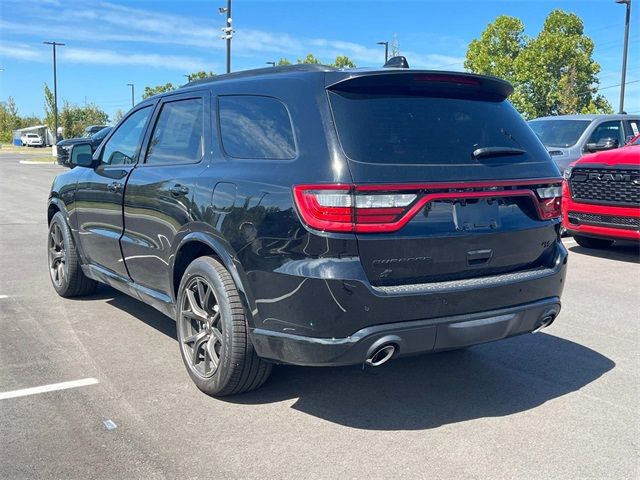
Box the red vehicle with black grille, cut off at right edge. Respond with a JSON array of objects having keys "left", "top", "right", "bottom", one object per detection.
[{"left": 562, "top": 135, "right": 640, "bottom": 248}]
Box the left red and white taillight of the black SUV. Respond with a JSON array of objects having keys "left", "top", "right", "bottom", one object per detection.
[{"left": 293, "top": 185, "right": 417, "bottom": 232}]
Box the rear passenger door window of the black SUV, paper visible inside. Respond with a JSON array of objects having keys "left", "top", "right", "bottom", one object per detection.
[{"left": 146, "top": 98, "right": 204, "bottom": 165}]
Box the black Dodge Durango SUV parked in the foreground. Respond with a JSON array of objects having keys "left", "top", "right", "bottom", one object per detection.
[{"left": 48, "top": 65, "right": 567, "bottom": 395}]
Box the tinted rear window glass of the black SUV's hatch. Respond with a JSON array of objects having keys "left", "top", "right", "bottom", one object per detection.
[{"left": 329, "top": 92, "right": 549, "bottom": 167}]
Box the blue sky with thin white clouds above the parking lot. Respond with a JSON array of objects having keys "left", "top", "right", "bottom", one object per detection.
[{"left": 0, "top": 0, "right": 640, "bottom": 120}]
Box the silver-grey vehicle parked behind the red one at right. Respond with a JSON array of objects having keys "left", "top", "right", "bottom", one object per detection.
[{"left": 529, "top": 114, "right": 640, "bottom": 172}]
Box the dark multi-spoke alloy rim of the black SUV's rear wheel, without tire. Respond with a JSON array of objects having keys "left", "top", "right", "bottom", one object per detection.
[{"left": 178, "top": 276, "right": 223, "bottom": 378}]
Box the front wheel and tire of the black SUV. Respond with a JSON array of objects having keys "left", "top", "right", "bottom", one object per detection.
[{"left": 47, "top": 212, "right": 98, "bottom": 298}]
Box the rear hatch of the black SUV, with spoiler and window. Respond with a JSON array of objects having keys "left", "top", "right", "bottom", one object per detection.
[{"left": 325, "top": 71, "right": 561, "bottom": 286}]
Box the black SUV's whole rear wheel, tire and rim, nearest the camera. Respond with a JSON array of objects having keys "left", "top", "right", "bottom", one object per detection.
[{"left": 176, "top": 256, "right": 272, "bottom": 397}]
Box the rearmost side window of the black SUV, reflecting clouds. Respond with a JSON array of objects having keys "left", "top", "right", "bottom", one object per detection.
[{"left": 218, "top": 95, "right": 296, "bottom": 160}]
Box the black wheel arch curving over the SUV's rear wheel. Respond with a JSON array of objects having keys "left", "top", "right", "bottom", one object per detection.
[{"left": 171, "top": 232, "right": 255, "bottom": 328}]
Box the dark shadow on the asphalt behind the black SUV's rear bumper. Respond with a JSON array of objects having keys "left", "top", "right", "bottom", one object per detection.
[{"left": 222, "top": 333, "right": 615, "bottom": 430}]
